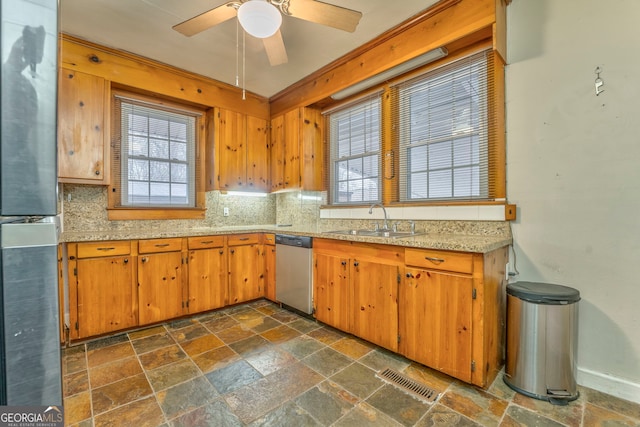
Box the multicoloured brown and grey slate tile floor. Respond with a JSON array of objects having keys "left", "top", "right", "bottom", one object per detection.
[{"left": 63, "top": 300, "right": 640, "bottom": 427}]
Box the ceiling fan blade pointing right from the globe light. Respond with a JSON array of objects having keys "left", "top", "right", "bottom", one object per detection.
[{"left": 289, "top": 0, "right": 362, "bottom": 33}]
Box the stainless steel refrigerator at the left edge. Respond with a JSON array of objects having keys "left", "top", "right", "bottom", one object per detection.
[{"left": 0, "top": 0, "right": 62, "bottom": 406}]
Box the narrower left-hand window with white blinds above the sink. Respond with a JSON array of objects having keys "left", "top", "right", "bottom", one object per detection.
[{"left": 328, "top": 93, "right": 382, "bottom": 205}]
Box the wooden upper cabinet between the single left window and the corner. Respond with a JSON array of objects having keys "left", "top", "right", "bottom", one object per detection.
[{"left": 208, "top": 108, "right": 269, "bottom": 191}]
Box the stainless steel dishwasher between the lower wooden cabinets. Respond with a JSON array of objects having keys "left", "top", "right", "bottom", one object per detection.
[{"left": 276, "top": 234, "right": 313, "bottom": 314}]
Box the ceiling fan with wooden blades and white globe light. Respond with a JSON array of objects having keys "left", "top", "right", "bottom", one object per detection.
[{"left": 173, "top": 0, "right": 362, "bottom": 65}]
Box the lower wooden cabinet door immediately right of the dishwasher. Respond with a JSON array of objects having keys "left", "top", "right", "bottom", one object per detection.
[{"left": 313, "top": 253, "right": 351, "bottom": 332}]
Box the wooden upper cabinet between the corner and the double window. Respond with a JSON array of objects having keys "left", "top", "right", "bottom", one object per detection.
[{"left": 271, "top": 107, "right": 324, "bottom": 191}]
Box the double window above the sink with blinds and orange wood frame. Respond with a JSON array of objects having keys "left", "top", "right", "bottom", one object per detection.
[{"left": 326, "top": 50, "right": 505, "bottom": 205}]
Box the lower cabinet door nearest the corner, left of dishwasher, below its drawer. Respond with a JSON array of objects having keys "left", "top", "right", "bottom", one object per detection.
[{"left": 229, "top": 244, "right": 264, "bottom": 304}]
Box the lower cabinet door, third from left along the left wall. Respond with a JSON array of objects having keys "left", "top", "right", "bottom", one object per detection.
[{"left": 188, "top": 248, "right": 229, "bottom": 313}]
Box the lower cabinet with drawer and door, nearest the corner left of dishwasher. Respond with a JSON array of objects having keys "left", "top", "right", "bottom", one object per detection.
[{"left": 227, "top": 234, "right": 264, "bottom": 304}]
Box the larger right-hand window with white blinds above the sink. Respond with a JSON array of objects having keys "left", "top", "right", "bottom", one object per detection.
[{"left": 392, "top": 53, "right": 493, "bottom": 202}]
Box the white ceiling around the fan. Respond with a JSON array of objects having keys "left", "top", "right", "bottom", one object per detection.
[{"left": 60, "top": 0, "right": 437, "bottom": 97}]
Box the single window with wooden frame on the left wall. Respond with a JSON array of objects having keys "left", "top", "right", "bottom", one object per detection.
[{"left": 109, "top": 93, "right": 202, "bottom": 219}]
